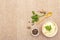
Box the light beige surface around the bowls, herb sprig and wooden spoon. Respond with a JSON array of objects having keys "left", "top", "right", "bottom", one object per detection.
[{"left": 0, "top": 0, "right": 60, "bottom": 40}]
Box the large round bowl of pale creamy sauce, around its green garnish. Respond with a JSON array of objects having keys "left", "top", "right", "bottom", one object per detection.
[{"left": 42, "top": 21, "right": 58, "bottom": 37}]
